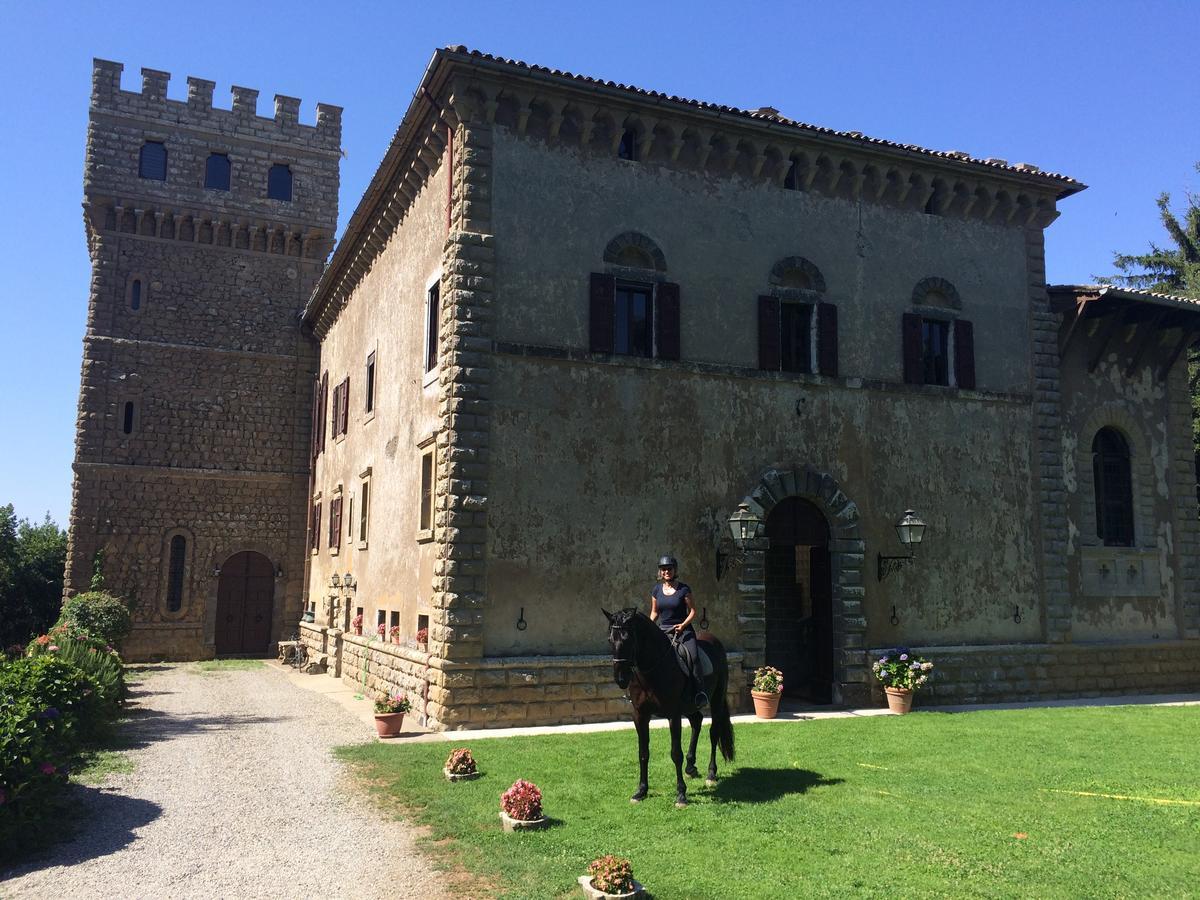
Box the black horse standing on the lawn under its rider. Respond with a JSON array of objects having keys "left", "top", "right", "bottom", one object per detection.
[{"left": 601, "top": 608, "right": 733, "bottom": 806}]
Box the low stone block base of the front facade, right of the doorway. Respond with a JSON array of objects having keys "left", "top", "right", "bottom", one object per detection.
[{"left": 871, "top": 641, "right": 1200, "bottom": 706}]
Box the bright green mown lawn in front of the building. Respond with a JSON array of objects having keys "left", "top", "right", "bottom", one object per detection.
[{"left": 340, "top": 706, "right": 1200, "bottom": 899}]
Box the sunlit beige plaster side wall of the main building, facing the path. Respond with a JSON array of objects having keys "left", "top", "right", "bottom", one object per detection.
[{"left": 308, "top": 153, "right": 448, "bottom": 640}]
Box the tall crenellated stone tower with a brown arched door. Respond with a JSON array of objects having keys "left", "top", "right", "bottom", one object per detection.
[{"left": 66, "top": 60, "right": 341, "bottom": 659}]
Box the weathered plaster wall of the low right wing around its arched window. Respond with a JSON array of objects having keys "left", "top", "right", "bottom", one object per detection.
[{"left": 1062, "top": 335, "right": 1196, "bottom": 641}]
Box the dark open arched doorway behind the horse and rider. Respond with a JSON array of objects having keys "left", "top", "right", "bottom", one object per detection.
[{"left": 763, "top": 497, "right": 834, "bottom": 703}]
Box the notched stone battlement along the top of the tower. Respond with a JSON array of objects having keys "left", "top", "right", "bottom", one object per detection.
[{"left": 91, "top": 59, "right": 342, "bottom": 151}]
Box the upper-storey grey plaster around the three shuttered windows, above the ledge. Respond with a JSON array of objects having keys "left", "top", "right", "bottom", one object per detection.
[{"left": 493, "top": 127, "right": 1030, "bottom": 391}]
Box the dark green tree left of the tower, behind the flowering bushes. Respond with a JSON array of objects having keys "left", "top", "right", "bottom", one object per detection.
[{"left": 0, "top": 504, "right": 67, "bottom": 649}]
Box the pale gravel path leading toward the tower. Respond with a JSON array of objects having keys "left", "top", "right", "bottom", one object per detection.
[{"left": 0, "top": 664, "right": 450, "bottom": 900}]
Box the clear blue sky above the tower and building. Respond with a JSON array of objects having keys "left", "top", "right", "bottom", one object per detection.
[{"left": 0, "top": 0, "right": 1200, "bottom": 524}]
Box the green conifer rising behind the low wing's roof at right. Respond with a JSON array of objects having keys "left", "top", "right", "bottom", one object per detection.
[{"left": 1099, "top": 162, "right": 1200, "bottom": 465}]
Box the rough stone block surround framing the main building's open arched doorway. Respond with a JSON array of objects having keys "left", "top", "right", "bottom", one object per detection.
[{"left": 738, "top": 466, "right": 869, "bottom": 706}]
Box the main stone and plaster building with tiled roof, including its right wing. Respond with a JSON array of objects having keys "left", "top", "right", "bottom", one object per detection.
[{"left": 72, "top": 48, "right": 1200, "bottom": 728}]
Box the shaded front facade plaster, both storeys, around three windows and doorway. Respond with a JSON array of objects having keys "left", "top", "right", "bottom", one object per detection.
[{"left": 485, "top": 127, "right": 1042, "bottom": 654}]
